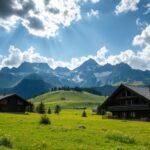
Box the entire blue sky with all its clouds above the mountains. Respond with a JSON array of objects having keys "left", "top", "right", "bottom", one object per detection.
[{"left": 0, "top": 0, "right": 150, "bottom": 70}]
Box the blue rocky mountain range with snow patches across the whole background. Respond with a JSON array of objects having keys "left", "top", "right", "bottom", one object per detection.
[{"left": 0, "top": 59, "right": 150, "bottom": 99}]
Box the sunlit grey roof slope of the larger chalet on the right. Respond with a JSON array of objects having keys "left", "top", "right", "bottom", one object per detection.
[{"left": 124, "top": 85, "right": 150, "bottom": 100}]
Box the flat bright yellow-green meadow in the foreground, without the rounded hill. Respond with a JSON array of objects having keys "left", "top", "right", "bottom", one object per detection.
[{"left": 0, "top": 110, "right": 150, "bottom": 150}]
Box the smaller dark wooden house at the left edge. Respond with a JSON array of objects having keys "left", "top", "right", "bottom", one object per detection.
[{"left": 0, "top": 94, "right": 32, "bottom": 112}]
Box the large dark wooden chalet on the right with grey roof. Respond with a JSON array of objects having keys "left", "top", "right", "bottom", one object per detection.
[{"left": 100, "top": 84, "right": 150, "bottom": 119}]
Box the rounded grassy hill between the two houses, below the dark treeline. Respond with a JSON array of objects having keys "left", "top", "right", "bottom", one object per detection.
[{"left": 31, "top": 91, "right": 105, "bottom": 108}]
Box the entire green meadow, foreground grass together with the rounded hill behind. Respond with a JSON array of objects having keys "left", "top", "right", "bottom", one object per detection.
[{"left": 0, "top": 91, "right": 150, "bottom": 150}]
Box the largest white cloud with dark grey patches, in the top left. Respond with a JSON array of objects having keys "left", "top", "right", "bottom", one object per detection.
[{"left": 0, "top": 0, "right": 81, "bottom": 38}]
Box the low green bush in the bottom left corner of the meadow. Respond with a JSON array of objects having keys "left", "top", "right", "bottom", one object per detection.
[{"left": 0, "top": 136, "right": 12, "bottom": 148}]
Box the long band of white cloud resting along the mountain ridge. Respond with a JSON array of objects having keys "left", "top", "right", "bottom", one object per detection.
[{"left": 0, "top": 43, "right": 150, "bottom": 70}]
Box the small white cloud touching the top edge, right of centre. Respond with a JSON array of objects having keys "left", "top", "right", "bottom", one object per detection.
[{"left": 115, "top": 0, "right": 140, "bottom": 15}]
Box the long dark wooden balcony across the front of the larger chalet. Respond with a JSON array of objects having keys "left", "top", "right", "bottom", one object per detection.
[{"left": 108, "top": 105, "right": 150, "bottom": 111}]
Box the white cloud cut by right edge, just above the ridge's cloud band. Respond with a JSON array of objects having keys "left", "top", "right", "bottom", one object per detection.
[{"left": 133, "top": 25, "right": 150, "bottom": 46}]
